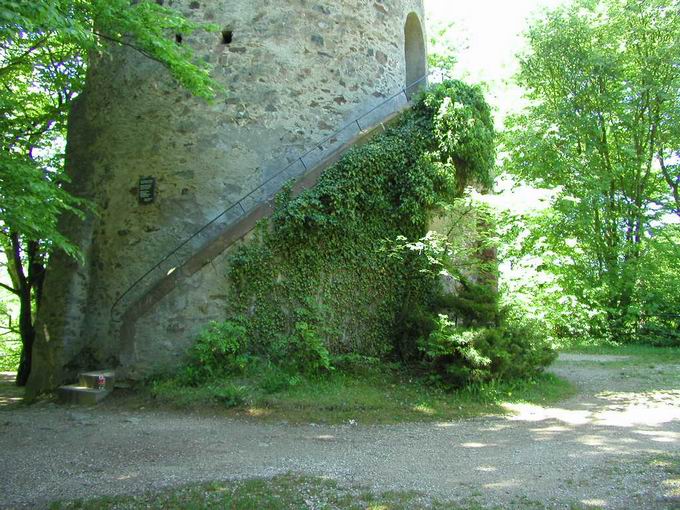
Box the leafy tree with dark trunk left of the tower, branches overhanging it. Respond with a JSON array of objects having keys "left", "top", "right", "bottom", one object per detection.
[{"left": 0, "top": 0, "right": 215, "bottom": 385}]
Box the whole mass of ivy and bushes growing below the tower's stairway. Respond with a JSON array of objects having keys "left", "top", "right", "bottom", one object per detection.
[{"left": 175, "top": 82, "right": 552, "bottom": 391}]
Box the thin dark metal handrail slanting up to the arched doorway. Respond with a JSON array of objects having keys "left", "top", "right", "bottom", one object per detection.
[{"left": 110, "top": 73, "right": 430, "bottom": 316}]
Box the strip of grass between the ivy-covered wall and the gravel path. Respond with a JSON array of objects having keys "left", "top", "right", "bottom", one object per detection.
[{"left": 135, "top": 365, "right": 575, "bottom": 424}]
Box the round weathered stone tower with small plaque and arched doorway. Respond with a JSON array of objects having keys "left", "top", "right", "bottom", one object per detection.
[{"left": 29, "top": 0, "right": 426, "bottom": 390}]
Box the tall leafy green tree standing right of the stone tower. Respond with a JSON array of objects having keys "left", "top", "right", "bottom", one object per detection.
[{"left": 505, "top": 0, "right": 680, "bottom": 339}]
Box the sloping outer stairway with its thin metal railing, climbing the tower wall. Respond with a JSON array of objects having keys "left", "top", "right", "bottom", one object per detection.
[{"left": 109, "top": 74, "right": 430, "bottom": 321}]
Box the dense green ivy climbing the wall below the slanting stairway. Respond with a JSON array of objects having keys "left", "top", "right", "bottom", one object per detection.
[{"left": 229, "top": 81, "right": 495, "bottom": 356}]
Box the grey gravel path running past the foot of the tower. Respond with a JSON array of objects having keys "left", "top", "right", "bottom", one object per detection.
[{"left": 0, "top": 356, "right": 680, "bottom": 509}]
